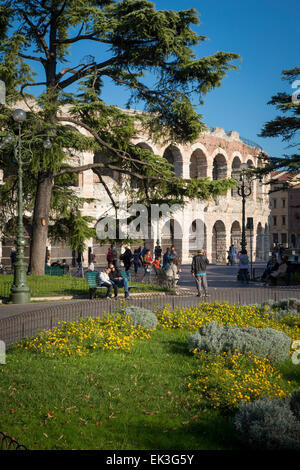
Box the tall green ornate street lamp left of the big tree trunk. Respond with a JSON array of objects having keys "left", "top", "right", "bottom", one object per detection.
[{"left": 0, "top": 109, "right": 52, "bottom": 304}]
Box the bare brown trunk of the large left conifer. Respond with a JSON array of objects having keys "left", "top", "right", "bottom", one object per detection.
[{"left": 29, "top": 176, "right": 53, "bottom": 275}]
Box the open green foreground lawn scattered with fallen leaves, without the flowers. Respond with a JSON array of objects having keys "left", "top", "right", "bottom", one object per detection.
[{"left": 0, "top": 330, "right": 236, "bottom": 450}]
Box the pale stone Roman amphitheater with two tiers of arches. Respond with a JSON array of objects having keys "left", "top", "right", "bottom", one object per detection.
[{"left": 1, "top": 117, "right": 270, "bottom": 265}]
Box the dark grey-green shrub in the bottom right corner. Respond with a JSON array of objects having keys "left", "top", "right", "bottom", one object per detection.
[{"left": 233, "top": 392, "right": 300, "bottom": 450}]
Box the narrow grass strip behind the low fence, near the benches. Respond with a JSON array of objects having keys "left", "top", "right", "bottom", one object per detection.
[{"left": 0, "top": 274, "right": 166, "bottom": 298}]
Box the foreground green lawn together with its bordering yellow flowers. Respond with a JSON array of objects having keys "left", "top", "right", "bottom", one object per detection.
[{"left": 0, "top": 303, "right": 300, "bottom": 451}]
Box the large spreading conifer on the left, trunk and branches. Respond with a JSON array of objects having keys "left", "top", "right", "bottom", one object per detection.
[{"left": 0, "top": 0, "right": 238, "bottom": 274}]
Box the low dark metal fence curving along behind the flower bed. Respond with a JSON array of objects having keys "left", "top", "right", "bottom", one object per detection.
[{"left": 0, "top": 288, "right": 300, "bottom": 345}]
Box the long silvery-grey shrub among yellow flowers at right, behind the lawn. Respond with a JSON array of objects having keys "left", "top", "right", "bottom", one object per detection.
[{"left": 189, "top": 322, "right": 291, "bottom": 362}]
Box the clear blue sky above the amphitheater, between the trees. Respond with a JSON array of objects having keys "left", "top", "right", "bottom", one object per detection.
[{"left": 24, "top": 0, "right": 300, "bottom": 157}]
